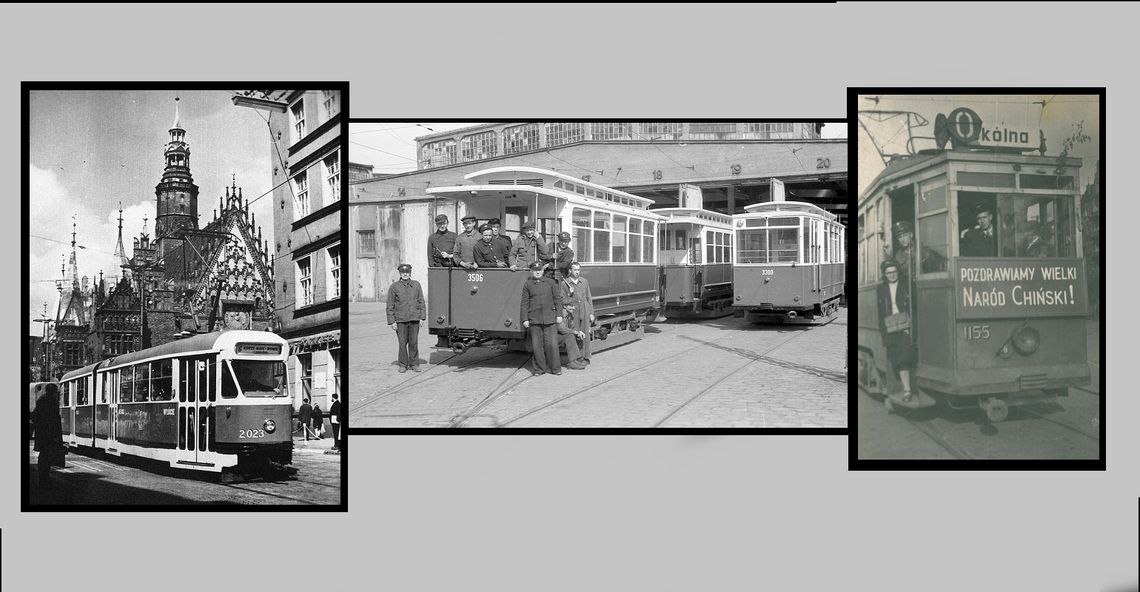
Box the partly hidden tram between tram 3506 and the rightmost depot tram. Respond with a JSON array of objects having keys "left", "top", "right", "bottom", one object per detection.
[{"left": 653, "top": 208, "right": 732, "bottom": 317}]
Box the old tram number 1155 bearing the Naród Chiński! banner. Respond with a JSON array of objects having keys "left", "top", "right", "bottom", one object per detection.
[{"left": 858, "top": 149, "right": 1090, "bottom": 421}]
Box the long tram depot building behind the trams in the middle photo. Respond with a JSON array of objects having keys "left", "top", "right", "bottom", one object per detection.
[{"left": 349, "top": 122, "right": 847, "bottom": 302}]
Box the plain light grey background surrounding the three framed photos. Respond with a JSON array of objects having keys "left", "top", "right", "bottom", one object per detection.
[{"left": 0, "top": 3, "right": 1140, "bottom": 591}]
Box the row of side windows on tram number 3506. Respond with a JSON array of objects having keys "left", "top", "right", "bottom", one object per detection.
[{"left": 571, "top": 208, "right": 657, "bottom": 263}]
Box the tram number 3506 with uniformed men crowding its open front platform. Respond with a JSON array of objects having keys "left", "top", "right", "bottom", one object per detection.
[{"left": 428, "top": 167, "right": 662, "bottom": 351}]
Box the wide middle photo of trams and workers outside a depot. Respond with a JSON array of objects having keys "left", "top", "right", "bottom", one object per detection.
[{"left": 348, "top": 120, "right": 848, "bottom": 433}]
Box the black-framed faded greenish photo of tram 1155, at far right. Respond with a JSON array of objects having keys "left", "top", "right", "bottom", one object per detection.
[{"left": 849, "top": 89, "right": 1105, "bottom": 469}]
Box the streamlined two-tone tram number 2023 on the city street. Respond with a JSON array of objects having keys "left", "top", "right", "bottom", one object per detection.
[{"left": 60, "top": 331, "right": 293, "bottom": 472}]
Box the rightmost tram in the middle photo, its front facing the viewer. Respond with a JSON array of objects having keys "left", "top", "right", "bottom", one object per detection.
[{"left": 733, "top": 202, "right": 846, "bottom": 323}]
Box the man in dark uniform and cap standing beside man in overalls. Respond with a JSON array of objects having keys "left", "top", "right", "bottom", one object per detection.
[{"left": 519, "top": 261, "right": 562, "bottom": 375}]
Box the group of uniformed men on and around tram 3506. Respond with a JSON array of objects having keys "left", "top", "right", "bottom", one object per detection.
[{"left": 388, "top": 214, "right": 595, "bottom": 375}]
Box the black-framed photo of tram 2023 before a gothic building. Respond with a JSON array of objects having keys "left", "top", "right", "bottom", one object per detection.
[{"left": 21, "top": 83, "right": 347, "bottom": 511}]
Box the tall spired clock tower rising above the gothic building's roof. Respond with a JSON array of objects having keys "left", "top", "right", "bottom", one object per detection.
[{"left": 154, "top": 97, "right": 198, "bottom": 241}]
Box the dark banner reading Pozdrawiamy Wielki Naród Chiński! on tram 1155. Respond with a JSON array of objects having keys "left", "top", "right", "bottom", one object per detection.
[{"left": 954, "top": 258, "right": 1089, "bottom": 318}]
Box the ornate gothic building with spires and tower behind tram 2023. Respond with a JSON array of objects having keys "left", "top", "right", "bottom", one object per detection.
[{"left": 50, "top": 99, "right": 280, "bottom": 378}]
